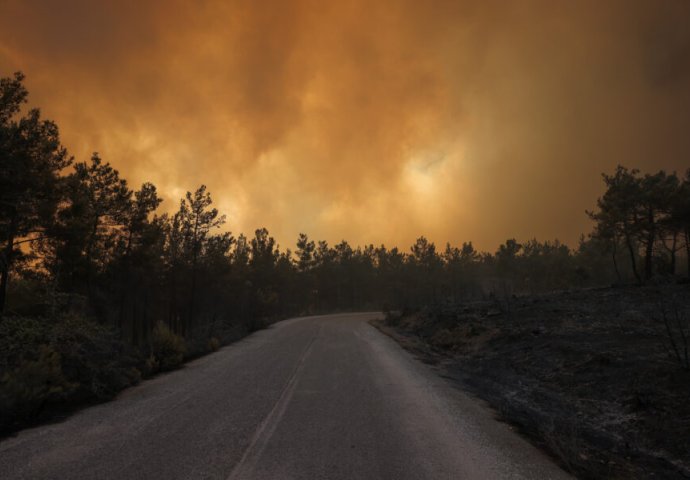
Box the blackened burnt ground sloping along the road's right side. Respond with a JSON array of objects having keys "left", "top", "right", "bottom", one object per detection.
[{"left": 376, "top": 285, "right": 690, "bottom": 479}]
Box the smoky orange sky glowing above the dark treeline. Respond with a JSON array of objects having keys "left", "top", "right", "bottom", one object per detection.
[{"left": 0, "top": 0, "right": 690, "bottom": 251}]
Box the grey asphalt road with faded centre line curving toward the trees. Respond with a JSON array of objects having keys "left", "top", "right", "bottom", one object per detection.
[{"left": 0, "top": 314, "right": 568, "bottom": 480}]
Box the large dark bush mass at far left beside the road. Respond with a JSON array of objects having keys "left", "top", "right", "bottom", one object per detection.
[{"left": 0, "top": 315, "right": 143, "bottom": 430}]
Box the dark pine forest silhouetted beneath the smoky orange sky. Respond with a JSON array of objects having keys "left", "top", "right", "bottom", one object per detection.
[{"left": 0, "top": 73, "right": 690, "bottom": 429}]
